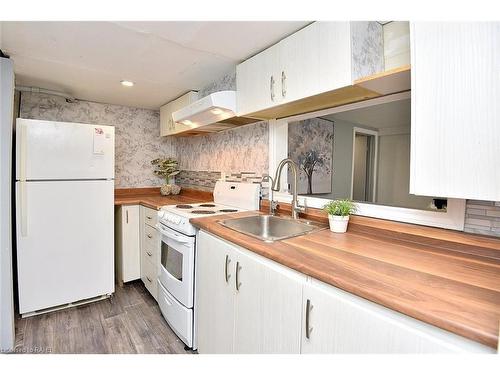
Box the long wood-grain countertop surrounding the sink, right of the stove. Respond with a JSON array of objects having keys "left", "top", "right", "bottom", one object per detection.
[{"left": 191, "top": 211, "right": 500, "bottom": 349}]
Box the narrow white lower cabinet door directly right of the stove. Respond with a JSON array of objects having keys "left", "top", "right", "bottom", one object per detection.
[{"left": 195, "top": 231, "right": 236, "bottom": 354}]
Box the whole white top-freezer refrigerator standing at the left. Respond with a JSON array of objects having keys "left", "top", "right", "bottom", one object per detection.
[{"left": 16, "top": 119, "right": 114, "bottom": 316}]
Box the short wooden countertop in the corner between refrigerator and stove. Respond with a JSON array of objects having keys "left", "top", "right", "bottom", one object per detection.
[{"left": 115, "top": 188, "right": 213, "bottom": 210}]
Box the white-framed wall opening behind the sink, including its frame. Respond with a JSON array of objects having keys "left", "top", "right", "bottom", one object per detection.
[{"left": 270, "top": 92, "right": 465, "bottom": 230}]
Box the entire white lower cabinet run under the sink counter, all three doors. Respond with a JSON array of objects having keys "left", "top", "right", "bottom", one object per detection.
[{"left": 195, "top": 231, "right": 494, "bottom": 354}]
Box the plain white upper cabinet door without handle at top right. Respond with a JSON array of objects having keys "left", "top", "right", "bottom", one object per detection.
[{"left": 410, "top": 22, "right": 500, "bottom": 201}]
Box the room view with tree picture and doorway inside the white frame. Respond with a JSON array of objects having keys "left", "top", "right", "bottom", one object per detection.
[{"left": 288, "top": 99, "right": 447, "bottom": 211}]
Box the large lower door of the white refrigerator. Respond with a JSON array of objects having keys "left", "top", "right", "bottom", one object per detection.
[{"left": 16, "top": 181, "right": 114, "bottom": 314}]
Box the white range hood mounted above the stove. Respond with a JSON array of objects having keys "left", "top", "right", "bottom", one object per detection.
[{"left": 172, "top": 90, "right": 259, "bottom": 135}]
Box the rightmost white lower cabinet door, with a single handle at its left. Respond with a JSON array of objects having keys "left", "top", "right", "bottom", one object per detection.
[{"left": 302, "top": 280, "right": 490, "bottom": 353}]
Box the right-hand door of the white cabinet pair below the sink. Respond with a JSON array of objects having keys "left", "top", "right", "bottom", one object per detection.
[{"left": 232, "top": 250, "right": 306, "bottom": 354}]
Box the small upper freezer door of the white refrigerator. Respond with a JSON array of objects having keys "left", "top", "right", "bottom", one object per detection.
[{"left": 16, "top": 119, "right": 115, "bottom": 180}]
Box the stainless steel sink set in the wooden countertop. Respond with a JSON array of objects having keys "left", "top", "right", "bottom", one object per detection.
[{"left": 219, "top": 215, "right": 324, "bottom": 242}]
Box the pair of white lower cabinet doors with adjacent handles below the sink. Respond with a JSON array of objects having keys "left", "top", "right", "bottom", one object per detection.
[{"left": 196, "top": 231, "right": 306, "bottom": 354}]
